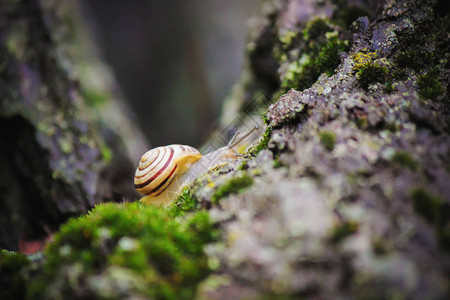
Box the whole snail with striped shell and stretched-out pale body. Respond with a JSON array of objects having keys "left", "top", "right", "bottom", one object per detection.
[{"left": 134, "top": 126, "right": 258, "bottom": 206}]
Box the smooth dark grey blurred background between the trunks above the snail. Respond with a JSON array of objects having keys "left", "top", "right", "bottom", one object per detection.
[{"left": 81, "top": 0, "right": 258, "bottom": 147}]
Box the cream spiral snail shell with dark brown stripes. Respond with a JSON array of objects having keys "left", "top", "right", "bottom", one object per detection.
[{"left": 134, "top": 145, "right": 201, "bottom": 197}]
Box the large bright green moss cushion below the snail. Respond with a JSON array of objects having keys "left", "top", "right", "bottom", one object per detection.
[{"left": 29, "top": 203, "right": 215, "bottom": 299}]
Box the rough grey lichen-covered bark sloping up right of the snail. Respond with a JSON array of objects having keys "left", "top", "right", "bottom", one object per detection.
[{"left": 196, "top": 0, "right": 450, "bottom": 299}]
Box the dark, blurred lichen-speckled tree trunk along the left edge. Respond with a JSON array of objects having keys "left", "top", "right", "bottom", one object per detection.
[{"left": 0, "top": 0, "right": 145, "bottom": 250}]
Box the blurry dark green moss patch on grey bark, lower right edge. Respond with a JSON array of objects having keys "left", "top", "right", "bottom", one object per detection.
[{"left": 411, "top": 188, "right": 443, "bottom": 224}]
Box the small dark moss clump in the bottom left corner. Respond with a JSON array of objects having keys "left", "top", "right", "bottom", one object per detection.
[{"left": 0, "top": 250, "right": 30, "bottom": 300}]
